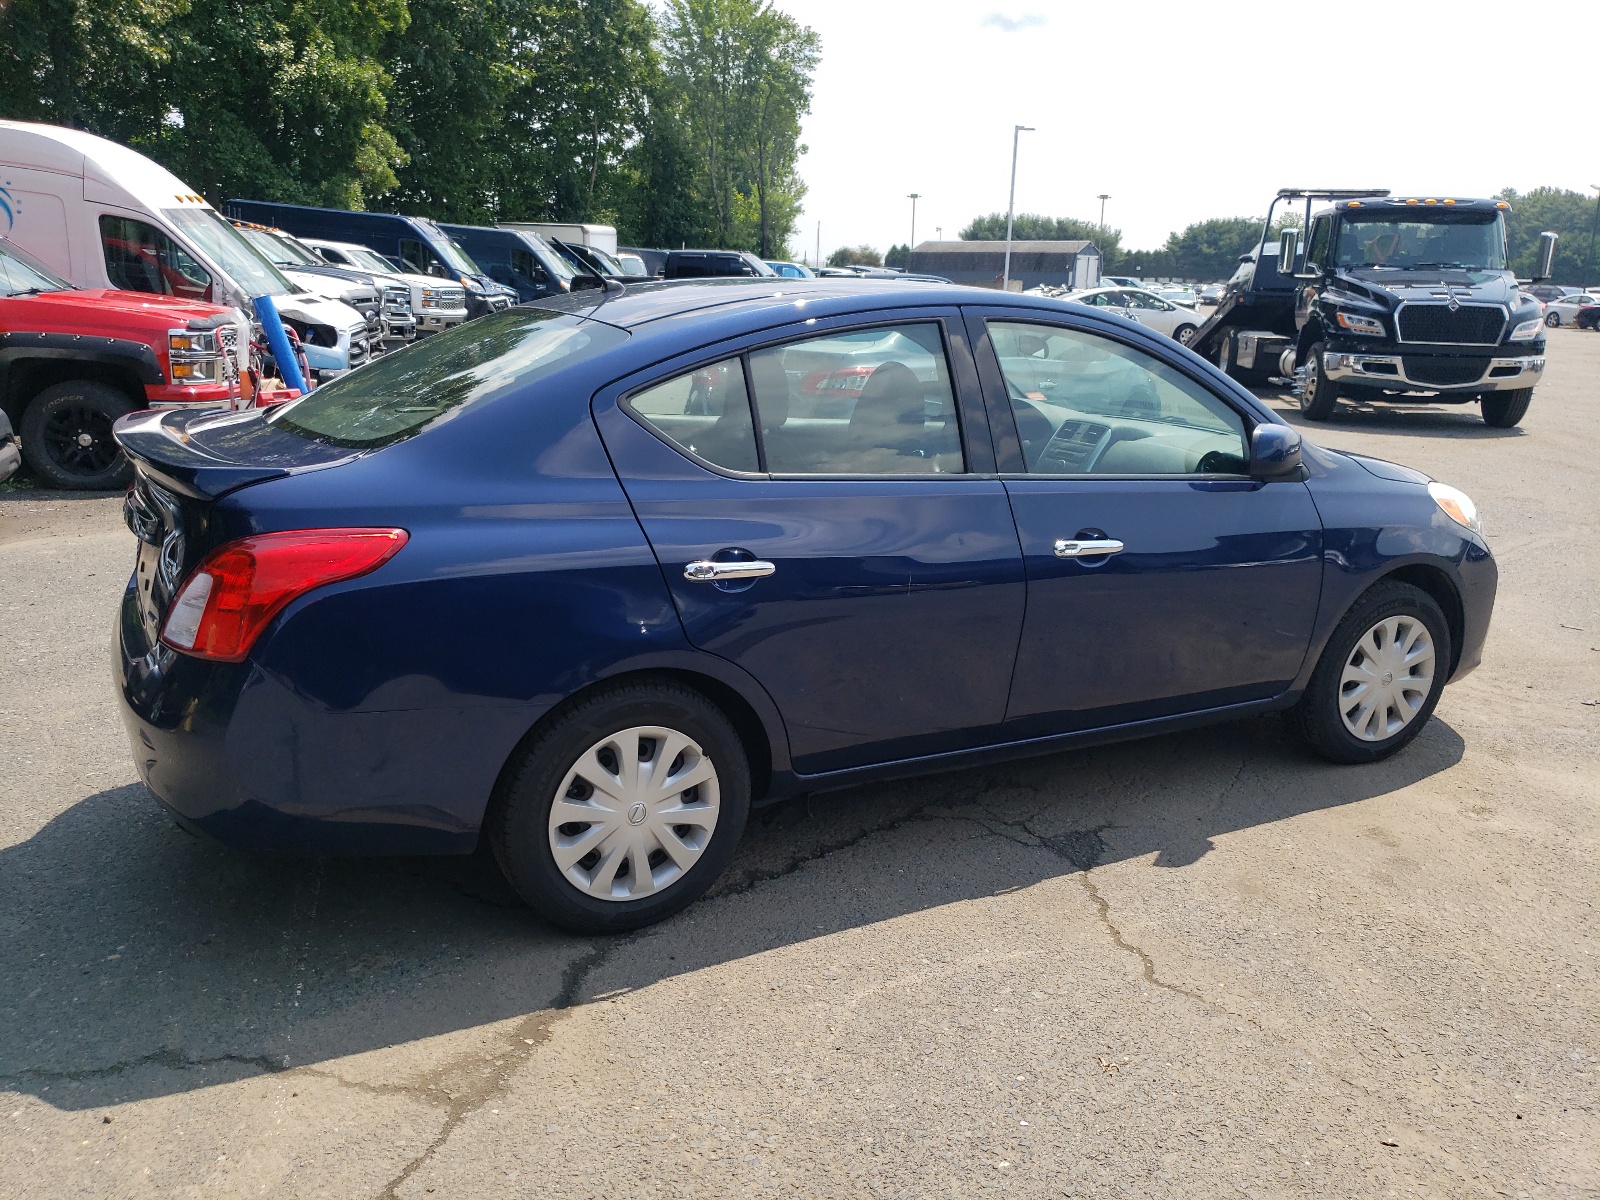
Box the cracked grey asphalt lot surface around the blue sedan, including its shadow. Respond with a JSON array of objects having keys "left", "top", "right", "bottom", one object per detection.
[{"left": 0, "top": 330, "right": 1600, "bottom": 1200}]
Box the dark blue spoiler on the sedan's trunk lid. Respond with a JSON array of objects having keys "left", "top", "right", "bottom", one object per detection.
[{"left": 112, "top": 410, "right": 357, "bottom": 501}]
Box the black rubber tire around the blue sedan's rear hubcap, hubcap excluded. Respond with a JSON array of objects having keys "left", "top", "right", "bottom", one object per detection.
[{"left": 488, "top": 682, "right": 750, "bottom": 934}]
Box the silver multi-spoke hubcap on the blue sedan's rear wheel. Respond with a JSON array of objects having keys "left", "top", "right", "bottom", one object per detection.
[{"left": 549, "top": 725, "right": 722, "bottom": 901}]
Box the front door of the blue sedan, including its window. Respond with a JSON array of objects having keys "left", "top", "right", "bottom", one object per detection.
[{"left": 968, "top": 309, "right": 1322, "bottom": 733}]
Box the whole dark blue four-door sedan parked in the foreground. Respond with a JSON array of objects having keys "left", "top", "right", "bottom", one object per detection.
[{"left": 115, "top": 280, "right": 1496, "bottom": 931}]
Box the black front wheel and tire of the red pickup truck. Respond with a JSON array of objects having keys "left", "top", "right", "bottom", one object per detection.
[{"left": 21, "top": 379, "right": 136, "bottom": 491}]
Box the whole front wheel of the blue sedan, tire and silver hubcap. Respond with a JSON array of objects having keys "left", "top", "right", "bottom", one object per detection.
[{"left": 1291, "top": 582, "right": 1451, "bottom": 763}]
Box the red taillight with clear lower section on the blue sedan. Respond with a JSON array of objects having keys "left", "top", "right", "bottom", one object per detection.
[{"left": 162, "top": 530, "right": 410, "bottom": 662}]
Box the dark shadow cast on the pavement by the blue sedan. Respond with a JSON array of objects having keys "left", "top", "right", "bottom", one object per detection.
[{"left": 0, "top": 717, "right": 1464, "bottom": 1110}]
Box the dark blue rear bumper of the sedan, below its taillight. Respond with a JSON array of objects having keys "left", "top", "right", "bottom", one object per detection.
[{"left": 112, "top": 586, "right": 512, "bottom": 854}]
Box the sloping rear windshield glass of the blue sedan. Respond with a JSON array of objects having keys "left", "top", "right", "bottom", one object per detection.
[{"left": 267, "top": 307, "right": 627, "bottom": 448}]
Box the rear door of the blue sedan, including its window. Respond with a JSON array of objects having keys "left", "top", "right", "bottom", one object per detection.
[{"left": 595, "top": 310, "right": 1024, "bottom": 774}]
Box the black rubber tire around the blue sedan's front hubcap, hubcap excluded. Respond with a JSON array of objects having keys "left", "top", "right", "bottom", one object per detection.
[{"left": 1290, "top": 582, "right": 1454, "bottom": 763}]
